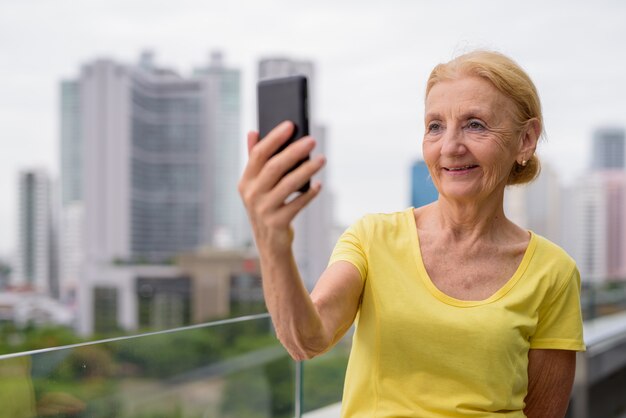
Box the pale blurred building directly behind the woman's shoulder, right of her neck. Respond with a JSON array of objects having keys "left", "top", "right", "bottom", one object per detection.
[{"left": 504, "top": 163, "right": 562, "bottom": 244}]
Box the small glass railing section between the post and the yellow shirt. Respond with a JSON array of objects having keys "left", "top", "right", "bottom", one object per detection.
[{"left": 302, "top": 335, "right": 352, "bottom": 413}]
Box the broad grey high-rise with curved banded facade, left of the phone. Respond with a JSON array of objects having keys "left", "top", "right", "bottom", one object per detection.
[{"left": 80, "top": 56, "right": 196, "bottom": 263}]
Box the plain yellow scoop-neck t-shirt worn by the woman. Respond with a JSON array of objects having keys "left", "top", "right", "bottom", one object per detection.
[{"left": 330, "top": 208, "right": 585, "bottom": 418}]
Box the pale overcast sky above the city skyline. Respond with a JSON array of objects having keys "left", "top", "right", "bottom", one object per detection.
[{"left": 0, "top": 0, "right": 626, "bottom": 254}]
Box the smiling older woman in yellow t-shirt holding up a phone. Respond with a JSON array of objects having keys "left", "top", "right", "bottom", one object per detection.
[{"left": 239, "top": 51, "right": 584, "bottom": 418}]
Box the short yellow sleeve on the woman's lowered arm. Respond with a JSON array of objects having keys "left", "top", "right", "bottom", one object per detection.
[{"left": 530, "top": 267, "right": 585, "bottom": 351}]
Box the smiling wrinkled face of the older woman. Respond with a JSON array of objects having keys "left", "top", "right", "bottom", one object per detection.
[{"left": 422, "top": 76, "right": 523, "bottom": 206}]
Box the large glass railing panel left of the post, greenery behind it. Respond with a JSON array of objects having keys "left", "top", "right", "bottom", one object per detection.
[{"left": 0, "top": 315, "right": 295, "bottom": 418}]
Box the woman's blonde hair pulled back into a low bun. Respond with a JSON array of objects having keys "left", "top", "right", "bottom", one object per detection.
[{"left": 426, "top": 50, "right": 544, "bottom": 185}]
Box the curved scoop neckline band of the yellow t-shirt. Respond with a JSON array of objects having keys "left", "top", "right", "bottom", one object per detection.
[{"left": 405, "top": 207, "right": 537, "bottom": 307}]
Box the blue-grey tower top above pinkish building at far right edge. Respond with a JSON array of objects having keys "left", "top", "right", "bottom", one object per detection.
[{"left": 591, "top": 127, "right": 625, "bottom": 171}]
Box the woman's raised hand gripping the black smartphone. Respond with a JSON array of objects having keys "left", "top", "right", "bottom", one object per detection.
[{"left": 239, "top": 122, "right": 325, "bottom": 253}]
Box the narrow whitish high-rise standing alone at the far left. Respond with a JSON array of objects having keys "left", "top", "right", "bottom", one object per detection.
[{"left": 11, "top": 170, "right": 56, "bottom": 293}]
